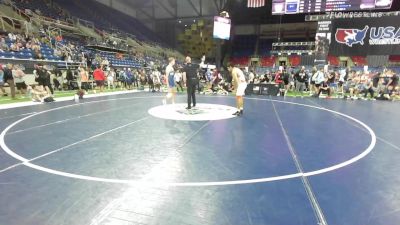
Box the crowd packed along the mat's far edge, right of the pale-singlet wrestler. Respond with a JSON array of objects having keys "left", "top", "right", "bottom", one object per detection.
[{"left": 248, "top": 66, "right": 400, "bottom": 100}]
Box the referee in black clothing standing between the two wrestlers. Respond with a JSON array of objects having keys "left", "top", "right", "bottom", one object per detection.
[{"left": 183, "top": 56, "right": 199, "bottom": 110}]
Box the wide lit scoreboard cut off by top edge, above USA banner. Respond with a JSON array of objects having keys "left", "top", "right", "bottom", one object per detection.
[{"left": 272, "top": 0, "right": 394, "bottom": 15}]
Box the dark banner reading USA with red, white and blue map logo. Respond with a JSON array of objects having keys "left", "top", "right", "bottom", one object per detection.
[{"left": 329, "top": 16, "right": 400, "bottom": 56}]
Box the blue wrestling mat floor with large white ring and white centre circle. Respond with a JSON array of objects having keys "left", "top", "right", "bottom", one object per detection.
[{"left": 0, "top": 93, "right": 400, "bottom": 225}]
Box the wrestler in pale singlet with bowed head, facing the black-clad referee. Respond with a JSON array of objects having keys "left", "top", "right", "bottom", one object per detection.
[{"left": 228, "top": 64, "right": 247, "bottom": 116}]
